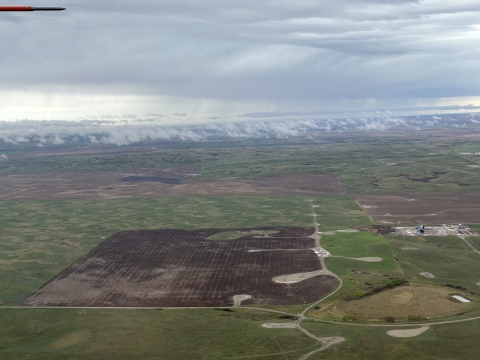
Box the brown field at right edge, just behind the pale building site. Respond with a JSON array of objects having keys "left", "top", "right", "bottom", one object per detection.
[{"left": 354, "top": 193, "right": 480, "bottom": 225}]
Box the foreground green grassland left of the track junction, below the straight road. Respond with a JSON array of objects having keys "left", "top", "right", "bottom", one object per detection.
[{"left": 0, "top": 309, "right": 317, "bottom": 360}]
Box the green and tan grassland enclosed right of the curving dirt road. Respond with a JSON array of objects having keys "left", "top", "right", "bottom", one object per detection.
[{"left": 309, "top": 232, "right": 480, "bottom": 322}]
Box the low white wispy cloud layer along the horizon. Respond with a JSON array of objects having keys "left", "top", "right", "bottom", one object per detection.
[{"left": 0, "top": 113, "right": 480, "bottom": 147}]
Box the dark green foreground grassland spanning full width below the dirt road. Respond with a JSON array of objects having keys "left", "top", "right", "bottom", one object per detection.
[{"left": 0, "top": 309, "right": 480, "bottom": 360}]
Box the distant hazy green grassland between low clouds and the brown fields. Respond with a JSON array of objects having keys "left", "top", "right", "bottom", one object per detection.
[{"left": 0, "top": 139, "right": 480, "bottom": 194}]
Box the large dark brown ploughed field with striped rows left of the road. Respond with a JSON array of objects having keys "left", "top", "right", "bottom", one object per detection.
[{"left": 20, "top": 227, "right": 337, "bottom": 307}]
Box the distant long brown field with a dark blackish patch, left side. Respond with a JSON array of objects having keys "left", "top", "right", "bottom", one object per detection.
[{"left": 0, "top": 167, "right": 347, "bottom": 201}]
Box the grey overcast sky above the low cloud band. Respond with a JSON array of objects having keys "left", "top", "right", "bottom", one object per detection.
[{"left": 0, "top": 0, "right": 480, "bottom": 121}]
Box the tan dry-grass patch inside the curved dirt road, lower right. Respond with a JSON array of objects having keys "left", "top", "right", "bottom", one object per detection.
[{"left": 314, "top": 285, "right": 471, "bottom": 321}]
